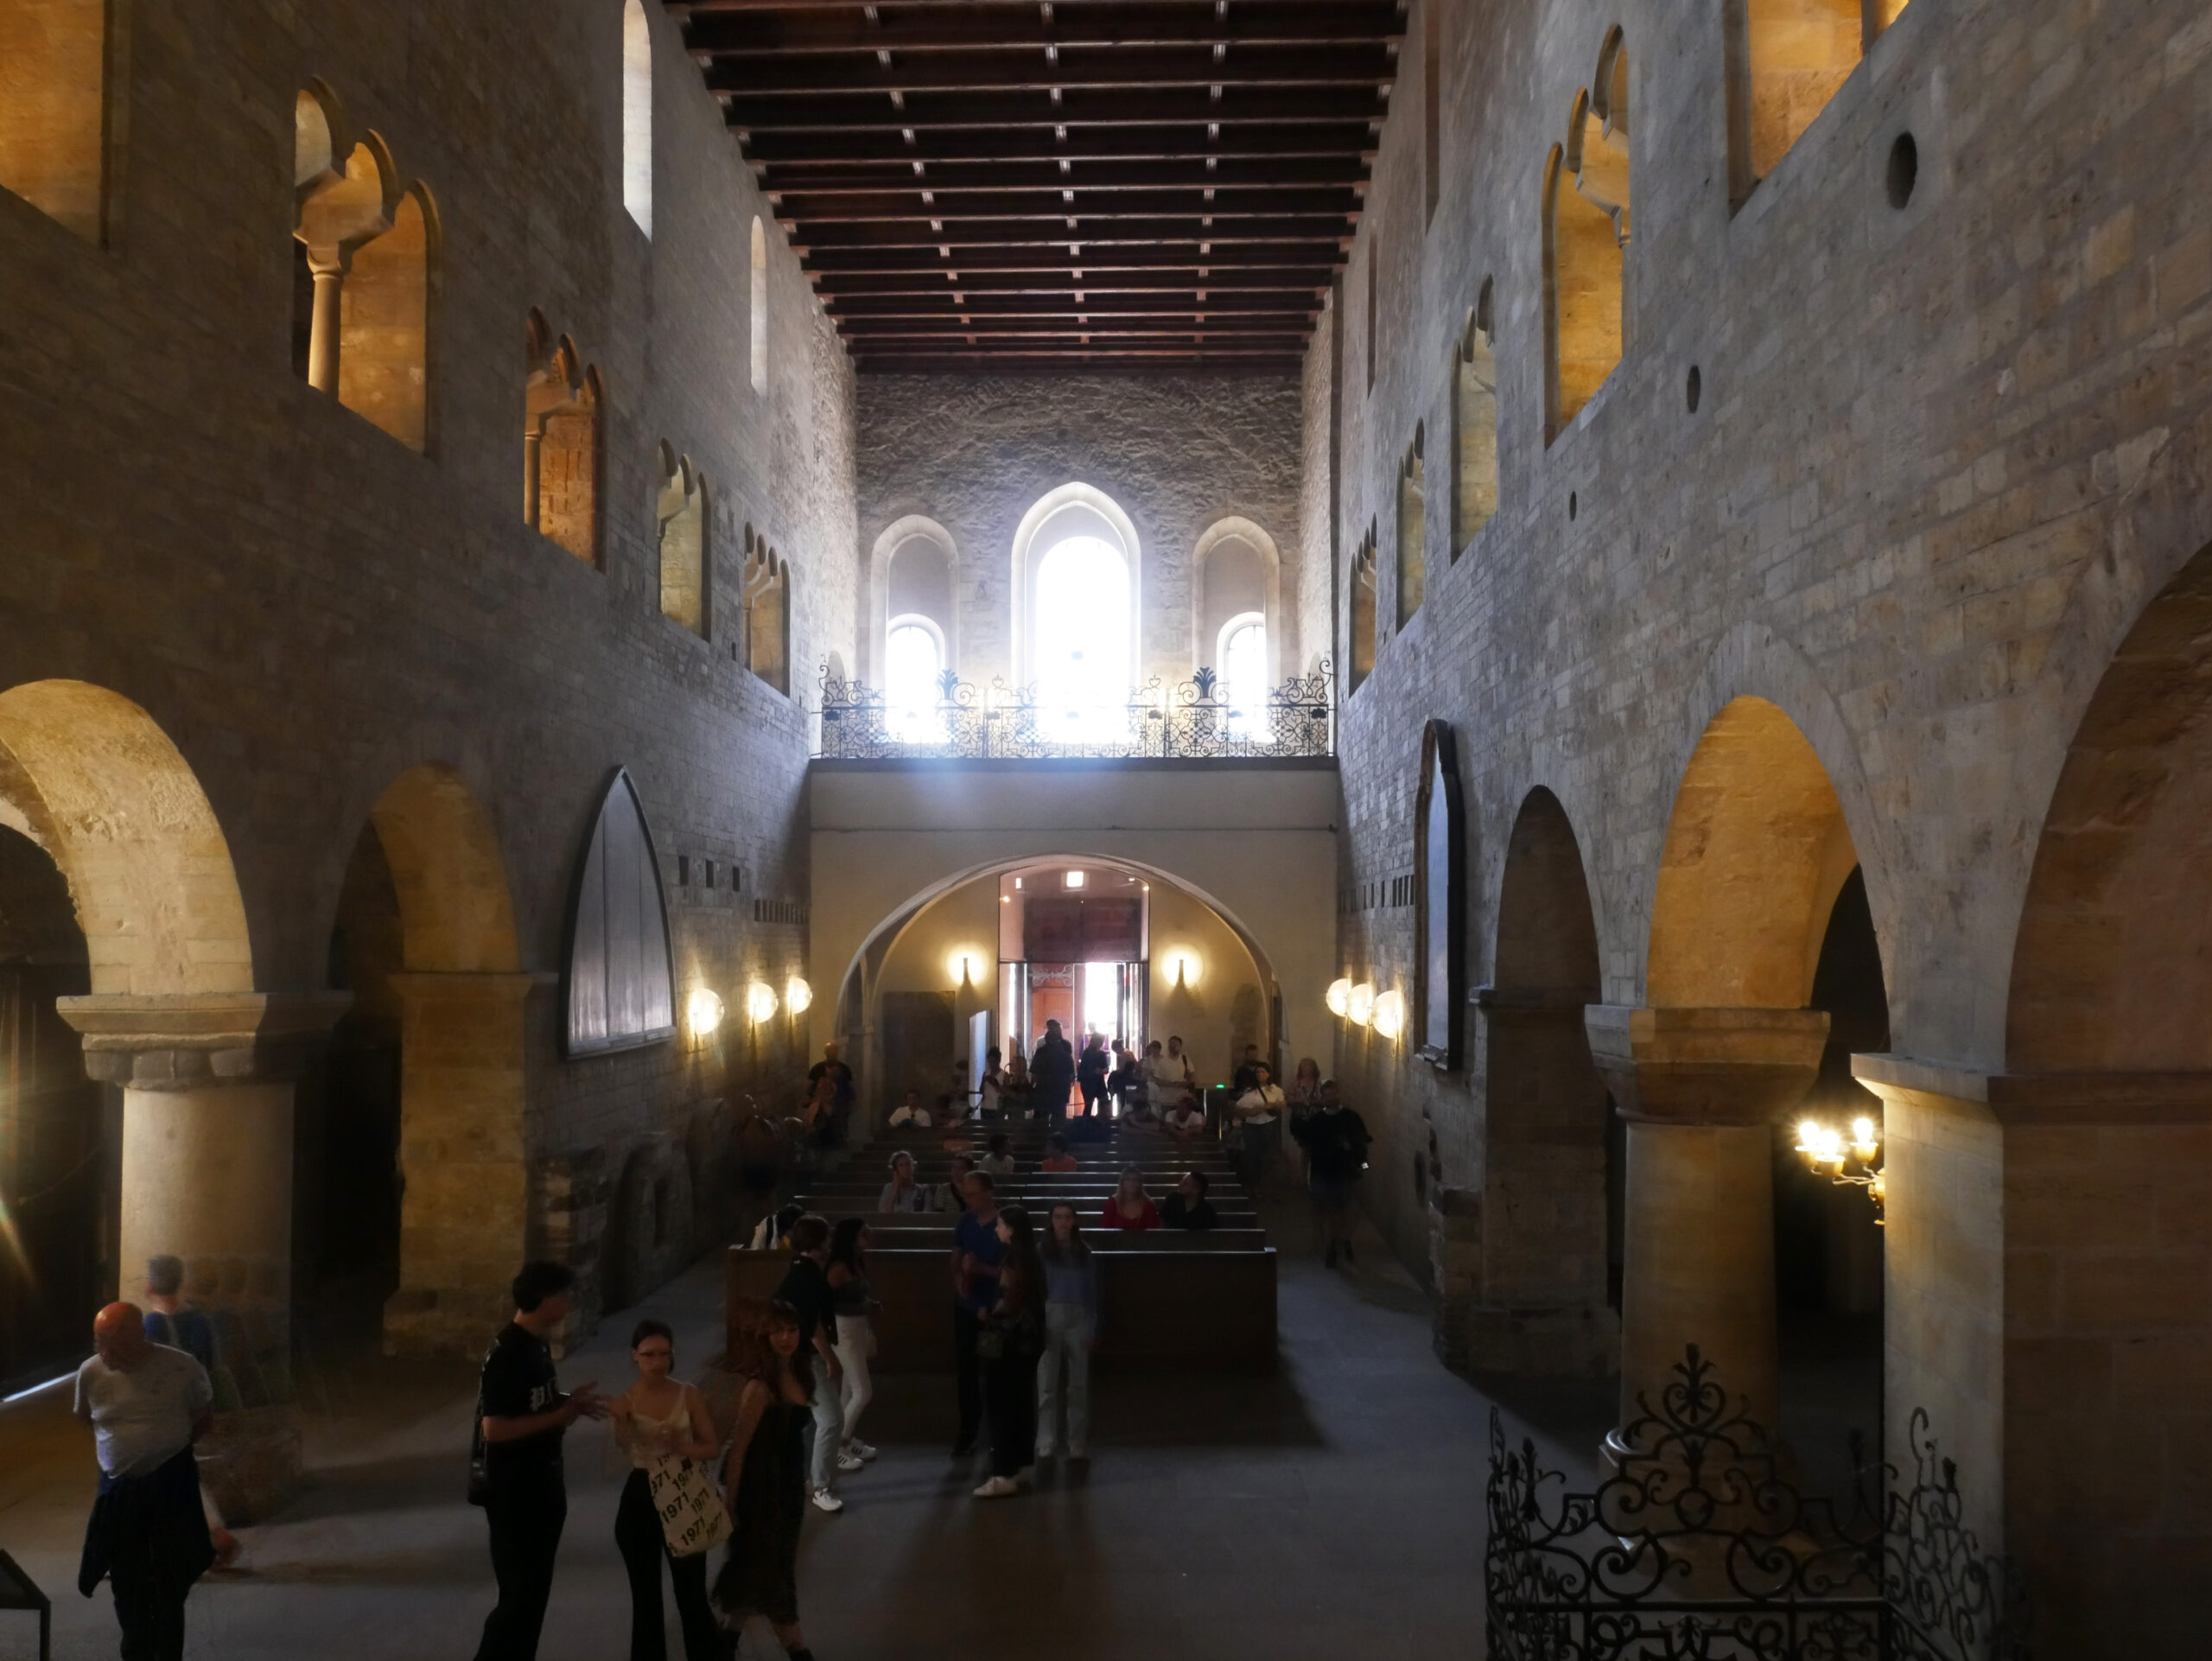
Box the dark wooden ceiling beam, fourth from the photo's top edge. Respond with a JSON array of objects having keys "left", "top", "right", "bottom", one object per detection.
[{"left": 746, "top": 122, "right": 1376, "bottom": 170}]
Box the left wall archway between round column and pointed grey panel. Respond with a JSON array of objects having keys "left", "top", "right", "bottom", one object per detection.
[{"left": 323, "top": 766, "right": 533, "bottom": 1352}]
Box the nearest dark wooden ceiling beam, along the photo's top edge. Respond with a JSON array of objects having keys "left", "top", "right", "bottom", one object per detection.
[{"left": 671, "top": 0, "right": 1405, "bottom": 58}]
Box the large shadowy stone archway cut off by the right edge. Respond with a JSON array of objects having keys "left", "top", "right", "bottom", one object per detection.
[{"left": 2008, "top": 546, "right": 2212, "bottom": 1657}]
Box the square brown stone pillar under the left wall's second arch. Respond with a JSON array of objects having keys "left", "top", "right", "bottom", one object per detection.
[{"left": 385, "top": 971, "right": 537, "bottom": 1356}]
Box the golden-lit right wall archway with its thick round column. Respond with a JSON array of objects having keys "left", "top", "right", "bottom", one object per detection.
[{"left": 1628, "top": 697, "right": 1887, "bottom": 1429}]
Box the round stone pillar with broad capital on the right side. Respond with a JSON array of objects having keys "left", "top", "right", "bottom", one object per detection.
[{"left": 1584, "top": 1004, "right": 1827, "bottom": 1447}]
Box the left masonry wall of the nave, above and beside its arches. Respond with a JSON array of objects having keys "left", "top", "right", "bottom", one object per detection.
[{"left": 0, "top": 0, "right": 856, "bottom": 1345}]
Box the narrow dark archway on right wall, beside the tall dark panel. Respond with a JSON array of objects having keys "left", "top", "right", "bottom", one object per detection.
[{"left": 1466, "top": 787, "right": 1621, "bottom": 1373}]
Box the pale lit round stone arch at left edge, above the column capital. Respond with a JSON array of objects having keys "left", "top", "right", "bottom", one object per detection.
[{"left": 0, "top": 681, "right": 254, "bottom": 997}]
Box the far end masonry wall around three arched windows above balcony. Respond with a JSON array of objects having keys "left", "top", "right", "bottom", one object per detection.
[{"left": 858, "top": 374, "right": 1300, "bottom": 685}]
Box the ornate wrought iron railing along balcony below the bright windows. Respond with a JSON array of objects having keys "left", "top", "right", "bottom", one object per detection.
[{"left": 814, "top": 661, "right": 1336, "bottom": 759}]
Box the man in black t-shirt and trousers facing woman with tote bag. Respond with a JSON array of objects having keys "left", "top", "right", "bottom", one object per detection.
[{"left": 471, "top": 1263, "right": 606, "bottom": 1661}]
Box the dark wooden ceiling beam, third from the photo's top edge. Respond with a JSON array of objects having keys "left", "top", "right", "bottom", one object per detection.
[{"left": 721, "top": 86, "right": 1387, "bottom": 131}]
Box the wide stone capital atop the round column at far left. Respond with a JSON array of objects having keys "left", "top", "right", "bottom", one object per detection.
[{"left": 55, "top": 991, "right": 354, "bottom": 1091}]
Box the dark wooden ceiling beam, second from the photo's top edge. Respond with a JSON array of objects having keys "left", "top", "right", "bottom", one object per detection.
[{"left": 706, "top": 42, "right": 1398, "bottom": 99}]
